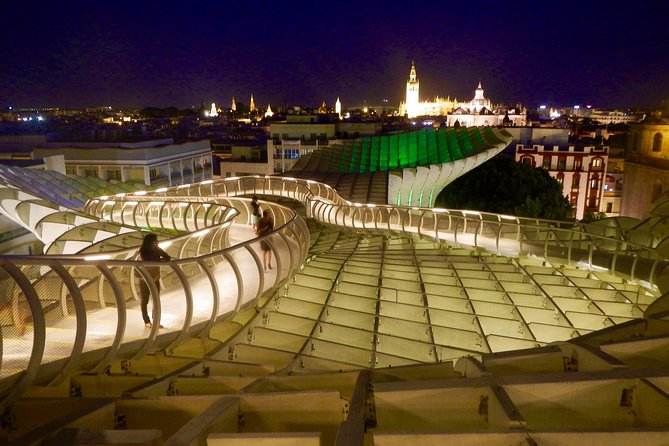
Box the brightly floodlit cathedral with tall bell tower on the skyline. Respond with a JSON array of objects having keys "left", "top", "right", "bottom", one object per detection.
[{"left": 400, "top": 62, "right": 527, "bottom": 126}]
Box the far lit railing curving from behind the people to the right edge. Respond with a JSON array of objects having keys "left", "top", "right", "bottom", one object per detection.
[{"left": 164, "top": 176, "right": 669, "bottom": 292}]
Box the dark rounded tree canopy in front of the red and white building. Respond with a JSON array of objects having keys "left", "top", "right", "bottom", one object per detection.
[{"left": 435, "top": 155, "right": 573, "bottom": 220}]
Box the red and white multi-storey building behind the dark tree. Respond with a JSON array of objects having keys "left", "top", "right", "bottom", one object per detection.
[{"left": 516, "top": 144, "right": 608, "bottom": 220}]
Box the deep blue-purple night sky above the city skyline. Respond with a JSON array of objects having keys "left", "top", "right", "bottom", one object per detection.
[{"left": 0, "top": 0, "right": 669, "bottom": 108}]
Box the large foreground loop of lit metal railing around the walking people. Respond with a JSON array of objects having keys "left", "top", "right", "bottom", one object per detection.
[{"left": 0, "top": 190, "right": 309, "bottom": 406}]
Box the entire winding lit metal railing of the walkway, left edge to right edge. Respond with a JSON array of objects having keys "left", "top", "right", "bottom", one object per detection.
[{"left": 0, "top": 176, "right": 667, "bottom": 412}]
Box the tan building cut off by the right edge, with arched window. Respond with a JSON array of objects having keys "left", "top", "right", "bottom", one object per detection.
[{"left": 620, "top": 120, "right": 669, "bottom": 218}]
